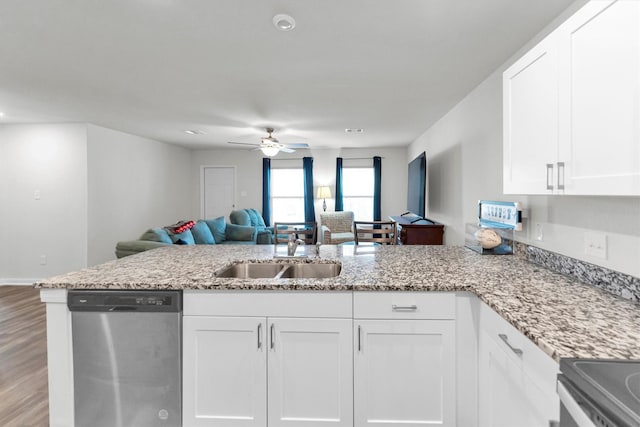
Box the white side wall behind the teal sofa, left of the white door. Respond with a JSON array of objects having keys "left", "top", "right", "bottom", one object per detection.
[{"left": 87, "top": 125, "right": 192, "bottom": 265}]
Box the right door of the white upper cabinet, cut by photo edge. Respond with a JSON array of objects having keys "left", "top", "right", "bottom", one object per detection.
[{"left": 559, "top": 0, "right": 640, "bottom": 195}]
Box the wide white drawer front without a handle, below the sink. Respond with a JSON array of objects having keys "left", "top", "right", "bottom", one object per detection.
[{"left": 183, "top": 291, "right": 353, "bottom": 318}]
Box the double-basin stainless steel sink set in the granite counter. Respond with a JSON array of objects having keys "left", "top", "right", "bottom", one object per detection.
[{"left": 215, "top": 262, "right": 342, "bottom": 279}]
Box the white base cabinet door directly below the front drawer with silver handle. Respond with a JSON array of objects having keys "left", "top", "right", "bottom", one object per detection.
[{"left": 354, "top": 320, "right": 456, "bottom": 427}]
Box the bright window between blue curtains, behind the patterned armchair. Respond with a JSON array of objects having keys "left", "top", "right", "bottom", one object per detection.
[{"left": 342, "top": 168, "right": 373, "bottom": 221}]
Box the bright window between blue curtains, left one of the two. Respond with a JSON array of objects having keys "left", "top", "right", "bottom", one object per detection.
[{"left": 271, "top": 168, "right": 304, "bottom": 223}]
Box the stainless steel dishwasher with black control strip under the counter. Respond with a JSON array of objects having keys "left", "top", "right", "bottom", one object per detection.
[{"left": 67, "top": 290, "right": 182, "bottom": 427}]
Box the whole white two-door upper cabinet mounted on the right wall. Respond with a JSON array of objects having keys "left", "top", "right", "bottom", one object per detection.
[{"left": 503, "top": 0, "right": 640, "bottom": 195}]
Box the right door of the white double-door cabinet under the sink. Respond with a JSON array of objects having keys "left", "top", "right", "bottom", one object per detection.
[{"left": 268, "top": 318, "right": 353, "bottom": 427}]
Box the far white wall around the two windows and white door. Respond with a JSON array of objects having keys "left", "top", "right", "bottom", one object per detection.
[{"left": 191, "top": 147, "right": 408, "bottom": 224}]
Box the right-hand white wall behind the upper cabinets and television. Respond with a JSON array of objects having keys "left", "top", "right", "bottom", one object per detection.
[{"left": 408, "top": 0, "right": 640, "bottom": 277}]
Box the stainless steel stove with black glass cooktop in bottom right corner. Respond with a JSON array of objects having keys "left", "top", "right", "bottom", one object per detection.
[{"left": 558, "top": 359, "right": 640, "bottom": 427}]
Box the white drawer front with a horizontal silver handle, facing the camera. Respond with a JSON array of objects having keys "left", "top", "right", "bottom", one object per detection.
[{"left": 353, "top": 292, "right": 456, "bottom": 319}]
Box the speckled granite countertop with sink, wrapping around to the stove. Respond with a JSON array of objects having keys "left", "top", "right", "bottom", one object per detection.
[{"left": 35, "top": 245, "right": 640, "bottom": 361}]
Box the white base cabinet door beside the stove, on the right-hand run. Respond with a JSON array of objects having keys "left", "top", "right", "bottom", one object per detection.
[{"left": 478, "top": 331, "right": 559, "bottom": 427}]
